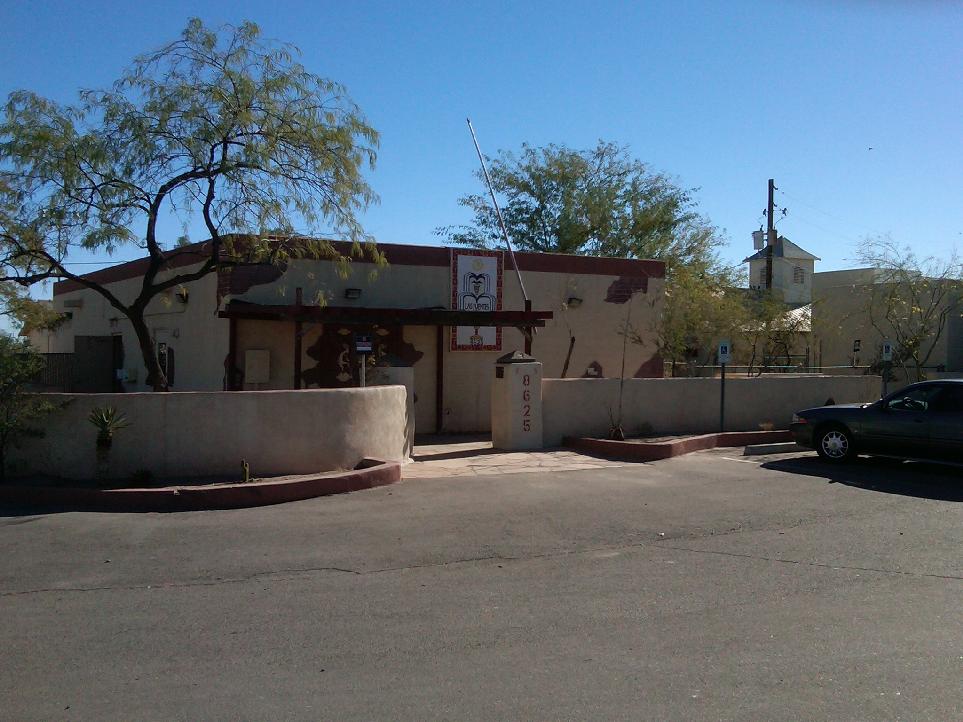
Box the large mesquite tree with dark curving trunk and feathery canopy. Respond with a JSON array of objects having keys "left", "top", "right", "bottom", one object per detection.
[{"left": 0, "top": 19, "right": 383, "bottom": 390}]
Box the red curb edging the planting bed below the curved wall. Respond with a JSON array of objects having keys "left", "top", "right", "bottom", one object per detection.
[{"left": 0, "top": 459, "right": 401, "bottom": 511}]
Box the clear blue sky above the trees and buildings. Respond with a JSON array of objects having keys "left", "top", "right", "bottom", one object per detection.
[{"left": 0, "top": 0, "right": 963, "bottom": 306}]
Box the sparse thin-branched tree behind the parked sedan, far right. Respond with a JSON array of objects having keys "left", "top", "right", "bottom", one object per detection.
[{"left": 859, "top": 238, "right": 963, "bottom": 381}]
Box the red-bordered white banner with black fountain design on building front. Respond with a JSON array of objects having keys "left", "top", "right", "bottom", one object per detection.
[{"left": 451, "top": 249, "right": 504, "bottom": 351}]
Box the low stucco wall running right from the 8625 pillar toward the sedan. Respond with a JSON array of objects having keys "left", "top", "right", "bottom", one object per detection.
[{"left": 542, "top": 376, "right": 880, "bottom": 446}]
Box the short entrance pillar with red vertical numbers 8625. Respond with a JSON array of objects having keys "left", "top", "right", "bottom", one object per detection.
[{"left": 492, "top": 351, "right": 542, "bottom": 450}]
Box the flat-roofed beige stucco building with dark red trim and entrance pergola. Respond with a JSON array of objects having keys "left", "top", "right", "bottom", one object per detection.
[{"left": 34, "top": 244, "right": 665, "bottom": 432}]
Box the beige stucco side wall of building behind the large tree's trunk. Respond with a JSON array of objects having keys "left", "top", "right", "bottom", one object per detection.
[{"left": 38, "top": 266, "right": 228, "bottom": 391}]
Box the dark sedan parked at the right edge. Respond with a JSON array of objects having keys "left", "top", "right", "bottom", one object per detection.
[{"left": 790, "top": 379, "right": 963, "bottom": 463}]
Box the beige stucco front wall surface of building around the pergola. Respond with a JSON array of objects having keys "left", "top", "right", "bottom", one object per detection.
[{"left": 232, "top": 261, "right": 664, "bottom": 433}]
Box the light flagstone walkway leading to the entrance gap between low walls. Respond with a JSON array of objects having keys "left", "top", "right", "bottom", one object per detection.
[{"left": 401, "top": 435, "right": 626, "bottom": 479}]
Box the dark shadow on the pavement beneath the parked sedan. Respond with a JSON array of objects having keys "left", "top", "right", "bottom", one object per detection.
[{"left": 762, "top": 455, "right": 963, "bottom": 501}]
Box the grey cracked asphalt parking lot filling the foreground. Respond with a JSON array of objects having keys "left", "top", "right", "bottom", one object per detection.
[{"left": 0, "top": 449, "right": 963, "bottom": 720}]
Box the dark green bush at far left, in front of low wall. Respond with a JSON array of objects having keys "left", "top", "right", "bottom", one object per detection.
[{"left": 0, "top": 334, "right": 54, "bottom": 478}]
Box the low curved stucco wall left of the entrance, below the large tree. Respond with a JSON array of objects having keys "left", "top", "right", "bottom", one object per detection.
[{"left": 11, "top": 386, "right": 413, "bottom": 479}]
